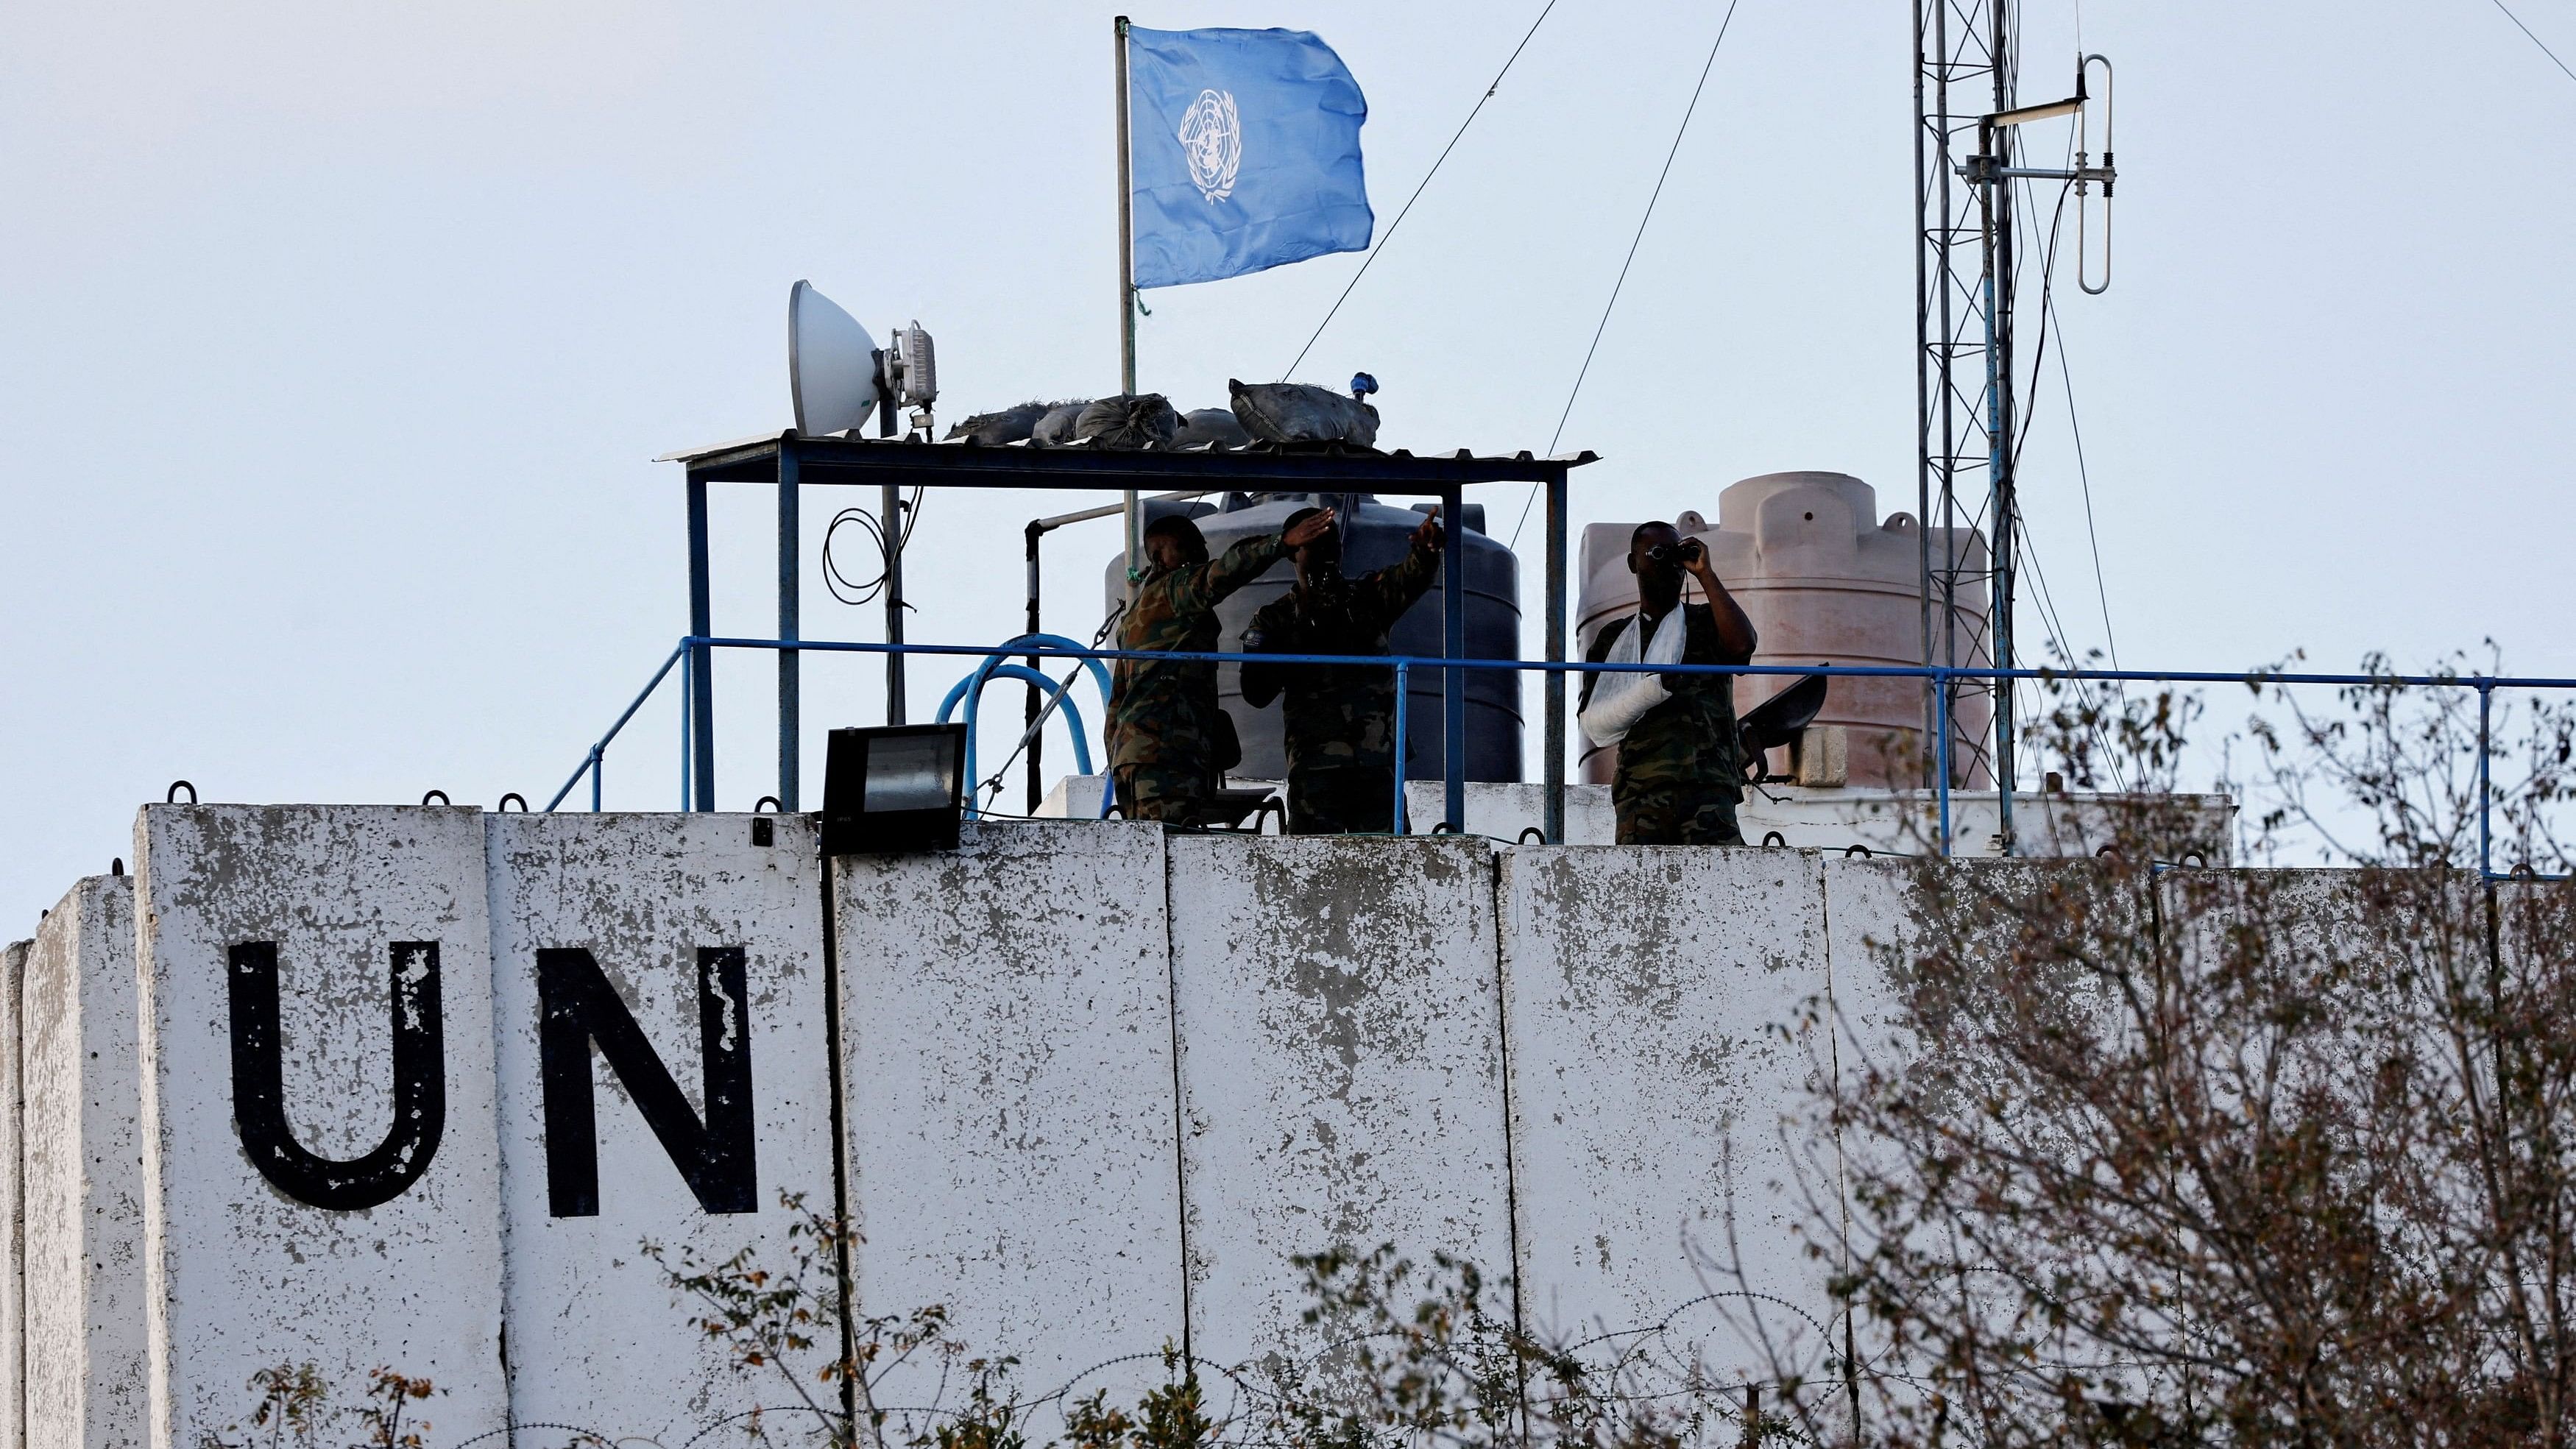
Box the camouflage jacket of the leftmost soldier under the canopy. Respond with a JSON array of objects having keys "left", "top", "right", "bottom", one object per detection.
[{"left": 1105, "top": 535, "right": 1281, "bottom": 772}]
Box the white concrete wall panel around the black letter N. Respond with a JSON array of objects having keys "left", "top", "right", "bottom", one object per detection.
[{"left": 484, "top": 813, "right": 840, "bottom": 1444}]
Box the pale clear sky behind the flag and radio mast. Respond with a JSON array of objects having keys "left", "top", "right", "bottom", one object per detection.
[{"left": 0, "top": 0, "right": 2576, "bottom": 911}]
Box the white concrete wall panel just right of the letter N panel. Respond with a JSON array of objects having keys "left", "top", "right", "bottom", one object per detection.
[{"left": 832, "top": 823, "right": 1183, "bottom": 1434}]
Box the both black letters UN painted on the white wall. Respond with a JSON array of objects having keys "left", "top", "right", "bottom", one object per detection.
[{"left": 227, "top": 942, "right": 760, "bottom": 1217}]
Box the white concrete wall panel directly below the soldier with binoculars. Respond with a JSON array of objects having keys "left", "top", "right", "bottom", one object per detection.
[{"left": 1502, "top": 847, "right": 1837, "bottom": 1382}]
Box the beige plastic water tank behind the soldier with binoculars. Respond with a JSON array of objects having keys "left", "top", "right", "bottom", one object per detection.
[{"left": 1574, "top": 474, "right": 1992, "bottom": 787}]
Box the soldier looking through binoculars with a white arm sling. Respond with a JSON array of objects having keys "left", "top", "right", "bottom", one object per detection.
[{"left": 1582, "top": 522, "right": 1755, "bottom": 844}]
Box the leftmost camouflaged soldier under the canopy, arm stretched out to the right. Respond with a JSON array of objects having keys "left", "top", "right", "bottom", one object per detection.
[{"left": 1108, "top": 512, "right": 1332, "bottom": 823}]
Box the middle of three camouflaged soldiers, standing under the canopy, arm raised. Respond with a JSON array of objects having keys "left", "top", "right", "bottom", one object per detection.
[{"left": 1245, "top": 509, "right": 1440, "bottom": 834}]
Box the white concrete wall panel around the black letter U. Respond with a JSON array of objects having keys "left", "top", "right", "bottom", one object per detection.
[{"left": 137, "top": 806, "right": 508, "bottom": 1449}]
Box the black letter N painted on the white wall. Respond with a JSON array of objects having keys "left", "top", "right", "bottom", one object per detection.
[{"left": 536, "top": 947, "right": 760, "bottom": 1217}]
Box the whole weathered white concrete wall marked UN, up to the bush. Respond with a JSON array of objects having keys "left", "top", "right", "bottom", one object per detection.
[{"left": 0, "top": 787, "right": 2318, "bottom": 1449}]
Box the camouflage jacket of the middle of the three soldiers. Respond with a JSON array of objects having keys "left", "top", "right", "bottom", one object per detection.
[{"left": 1245, "top": 548, "right": 1440, "bottom": 777}]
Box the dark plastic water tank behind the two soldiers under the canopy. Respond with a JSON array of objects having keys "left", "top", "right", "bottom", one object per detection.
[{"left": 1105, "top": 494, "right": 1520, "bottom": 780}]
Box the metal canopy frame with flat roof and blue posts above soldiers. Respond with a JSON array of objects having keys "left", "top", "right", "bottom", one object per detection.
[{"left": 654, "top": 428, "right": 1597, "bottom": 842}]
